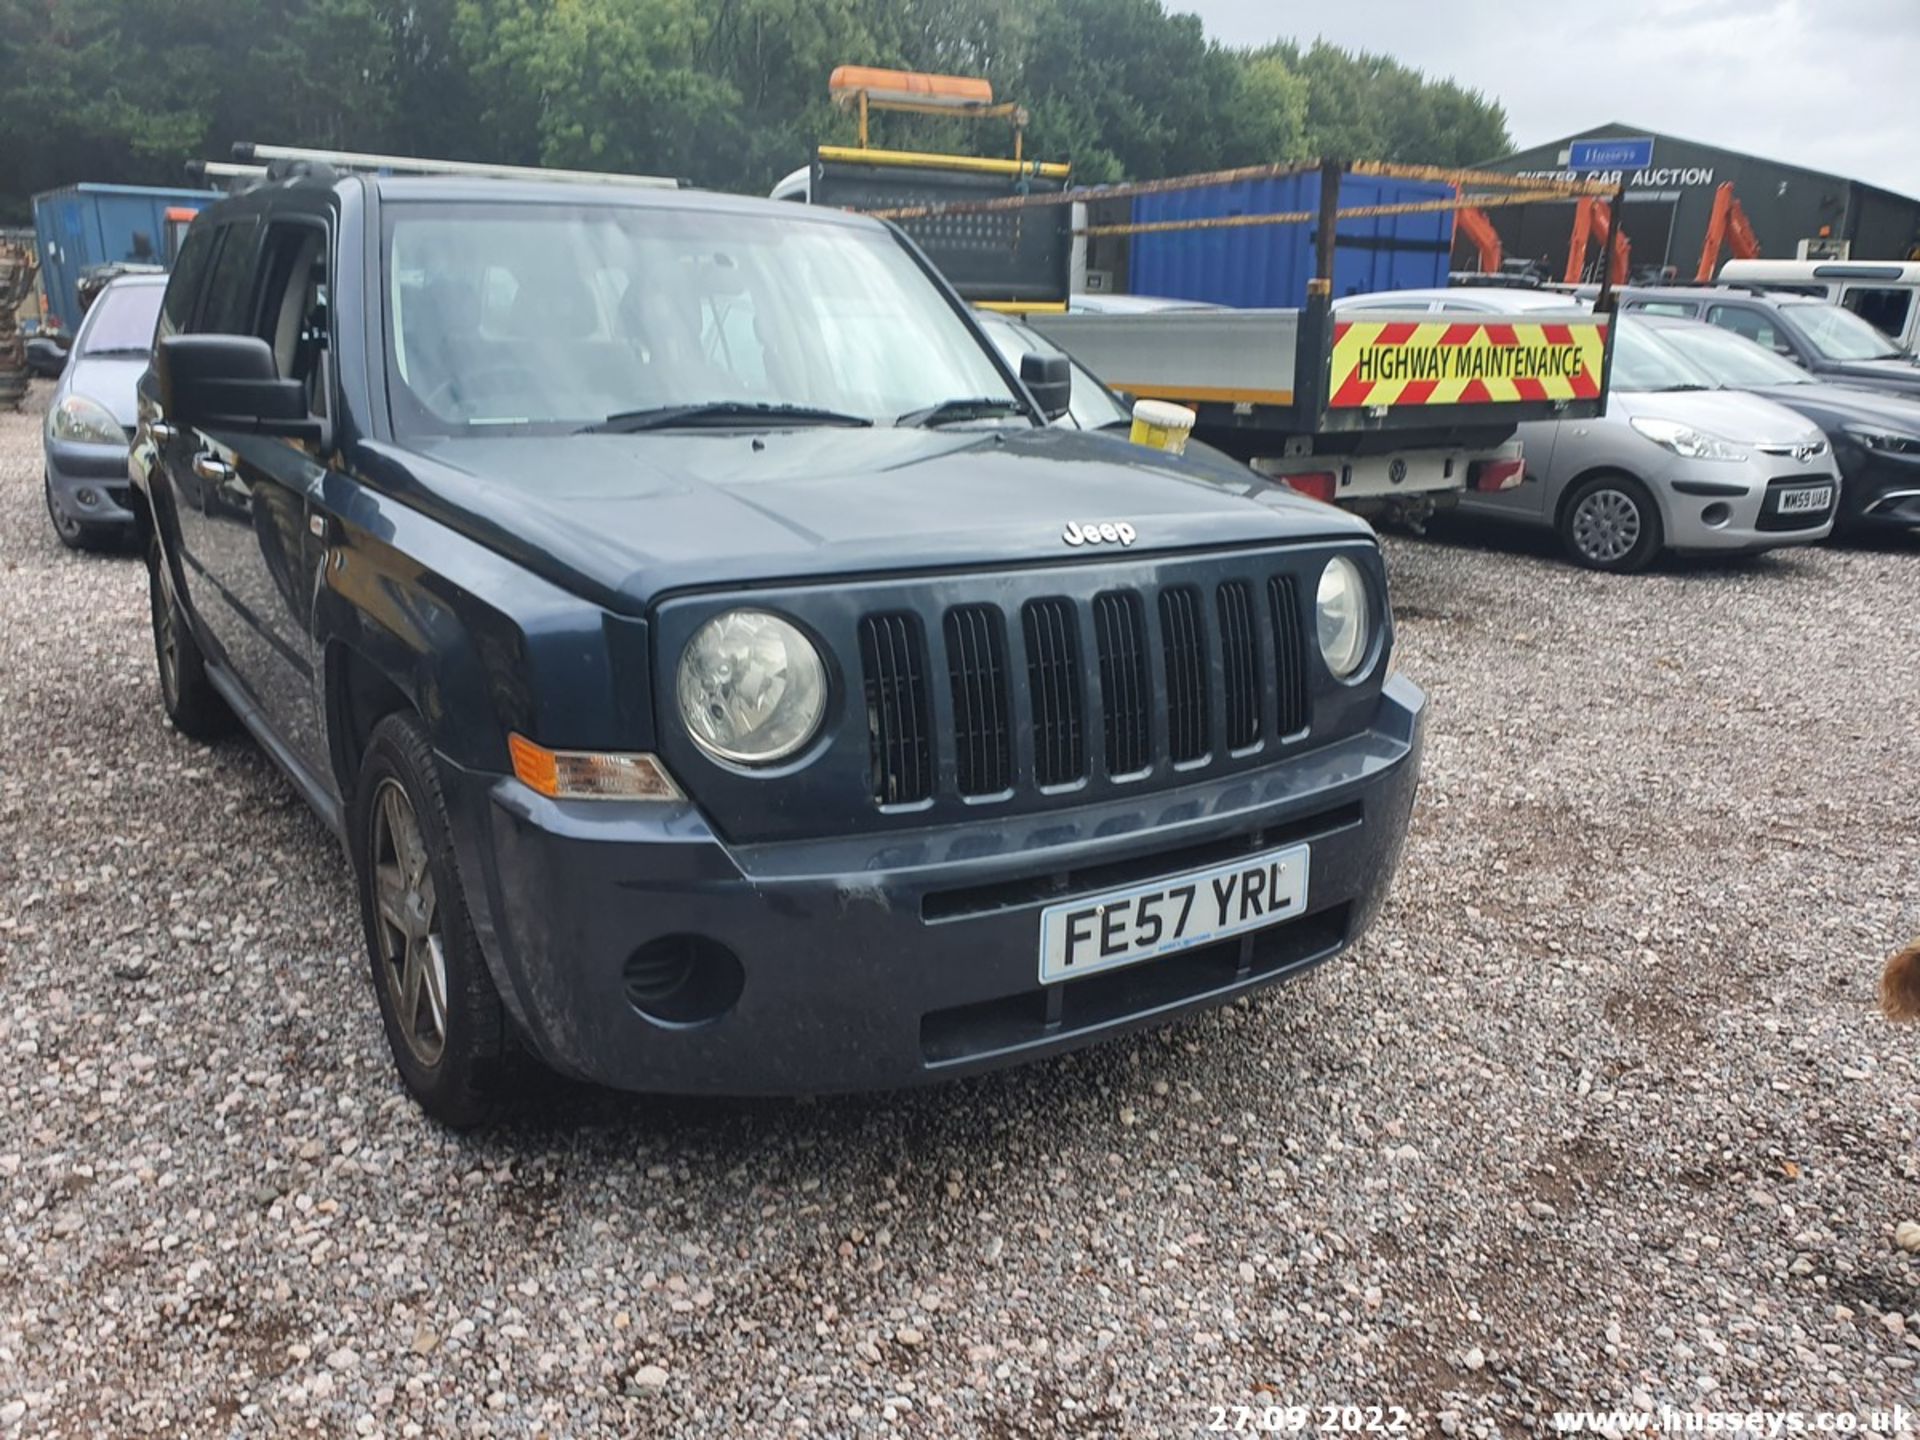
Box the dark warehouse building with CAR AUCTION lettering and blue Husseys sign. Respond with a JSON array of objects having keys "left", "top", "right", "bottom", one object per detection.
[{"left": 1453, "top": 125, "right": 1920, "bottom": 280}]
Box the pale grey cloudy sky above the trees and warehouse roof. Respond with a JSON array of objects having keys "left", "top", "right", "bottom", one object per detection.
[{"left": 1167, "top": 0, "right": 1920, "bottom": 196}]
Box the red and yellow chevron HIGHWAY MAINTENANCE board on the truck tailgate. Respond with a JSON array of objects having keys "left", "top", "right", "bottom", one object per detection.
[{"left": 1329, "top": 319, "right": 1607, "bottom": 407}]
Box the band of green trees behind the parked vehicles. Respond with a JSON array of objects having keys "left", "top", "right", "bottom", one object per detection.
[{"left": 0, "top": 0, "right": 1507, "bottom": 219}]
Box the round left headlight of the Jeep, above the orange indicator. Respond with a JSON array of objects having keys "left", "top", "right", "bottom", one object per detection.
[{"left": 676, "top": 611, "right": 828, "bottom": 764}]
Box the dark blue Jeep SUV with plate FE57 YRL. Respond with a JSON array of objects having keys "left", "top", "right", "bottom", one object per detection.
[{"left": 131, "top": 171, "right": 1423, "bottom": 1125}]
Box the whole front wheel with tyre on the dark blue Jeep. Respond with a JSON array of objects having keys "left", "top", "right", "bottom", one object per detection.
[{"left": 351, "top": 712, "right": 520, "bottom": 1129}]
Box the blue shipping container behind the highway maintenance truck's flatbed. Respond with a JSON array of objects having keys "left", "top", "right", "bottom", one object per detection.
[{"left": 1127, "top": 171, "right": 1453, "bottom": 309}]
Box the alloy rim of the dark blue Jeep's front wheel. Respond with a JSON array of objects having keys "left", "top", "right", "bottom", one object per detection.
[{"left": 372, "top": 780, "right": 447, "bottom": 1066}]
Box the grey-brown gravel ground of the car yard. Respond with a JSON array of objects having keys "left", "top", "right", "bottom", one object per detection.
[{"left": 0, "top": 386, "right": 1920, "bottom": 1438}]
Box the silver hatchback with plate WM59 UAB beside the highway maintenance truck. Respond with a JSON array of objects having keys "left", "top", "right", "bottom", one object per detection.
[{"left": 1459, "top": 315, "right": 1839, "bottom": 572}]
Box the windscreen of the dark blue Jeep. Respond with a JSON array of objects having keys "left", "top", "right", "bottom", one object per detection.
[{"left": 386, "top": 205, "right": 1014, "bottom": 434}]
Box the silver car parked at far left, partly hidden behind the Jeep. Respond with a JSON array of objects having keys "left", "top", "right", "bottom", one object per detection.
[{"left": 44, "top": 275, "right": 167, "bottom": 549}]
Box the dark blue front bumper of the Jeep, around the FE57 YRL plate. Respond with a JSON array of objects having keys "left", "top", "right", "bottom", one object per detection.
[{"left": 444, "top": 676, "right": 1425, "bottom": 1094}]
